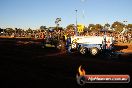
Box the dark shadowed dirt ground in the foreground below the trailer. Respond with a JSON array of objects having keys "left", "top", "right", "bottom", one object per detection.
[{"left": 0, "top": 38, "right": 132, "bottom": 88}]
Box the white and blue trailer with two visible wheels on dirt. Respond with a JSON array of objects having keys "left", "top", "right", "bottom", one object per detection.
[{"left": 66, "top": 35, "right": 114, "bottom": 56}]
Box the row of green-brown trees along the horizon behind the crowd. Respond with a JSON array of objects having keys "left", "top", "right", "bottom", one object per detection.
[{"left": 0, "top": 21, "right": 132, "bottom": 35}]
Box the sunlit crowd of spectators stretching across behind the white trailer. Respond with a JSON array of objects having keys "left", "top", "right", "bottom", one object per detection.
[{"left": 1, "top": 30, "right": 132, "bottom": 43}]
